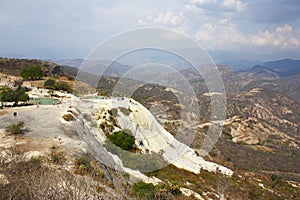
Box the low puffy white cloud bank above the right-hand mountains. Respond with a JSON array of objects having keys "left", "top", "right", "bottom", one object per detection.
[{"left": 194, "top": 23, "right": 300, "bottom": 49}]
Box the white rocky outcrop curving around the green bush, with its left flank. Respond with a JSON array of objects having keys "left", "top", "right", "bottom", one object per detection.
[{"left": 77, "top": 98, "right": 233, "bottom": 176}]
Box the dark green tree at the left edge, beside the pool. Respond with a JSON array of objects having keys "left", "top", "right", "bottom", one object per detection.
[{"left": 0, "top": 87, "right": 29, "bottom": 105}]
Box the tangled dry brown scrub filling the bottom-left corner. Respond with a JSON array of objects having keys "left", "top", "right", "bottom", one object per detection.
[{"left": 0, "top": 149, "right": 130, "bottom": 200}]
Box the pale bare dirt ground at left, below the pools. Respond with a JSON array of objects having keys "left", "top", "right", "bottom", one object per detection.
[{"left": 0, "top": 100, "right": 86, "bottom": 164}]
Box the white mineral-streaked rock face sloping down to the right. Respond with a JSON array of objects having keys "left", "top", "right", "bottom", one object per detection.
[{"left": 74, "top": 98, "right": 233, "bottom": 176}]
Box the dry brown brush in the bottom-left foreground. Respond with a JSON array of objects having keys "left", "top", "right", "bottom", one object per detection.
[{"left": 0, "top": 159, "right": 118, "bottom": 200}]
